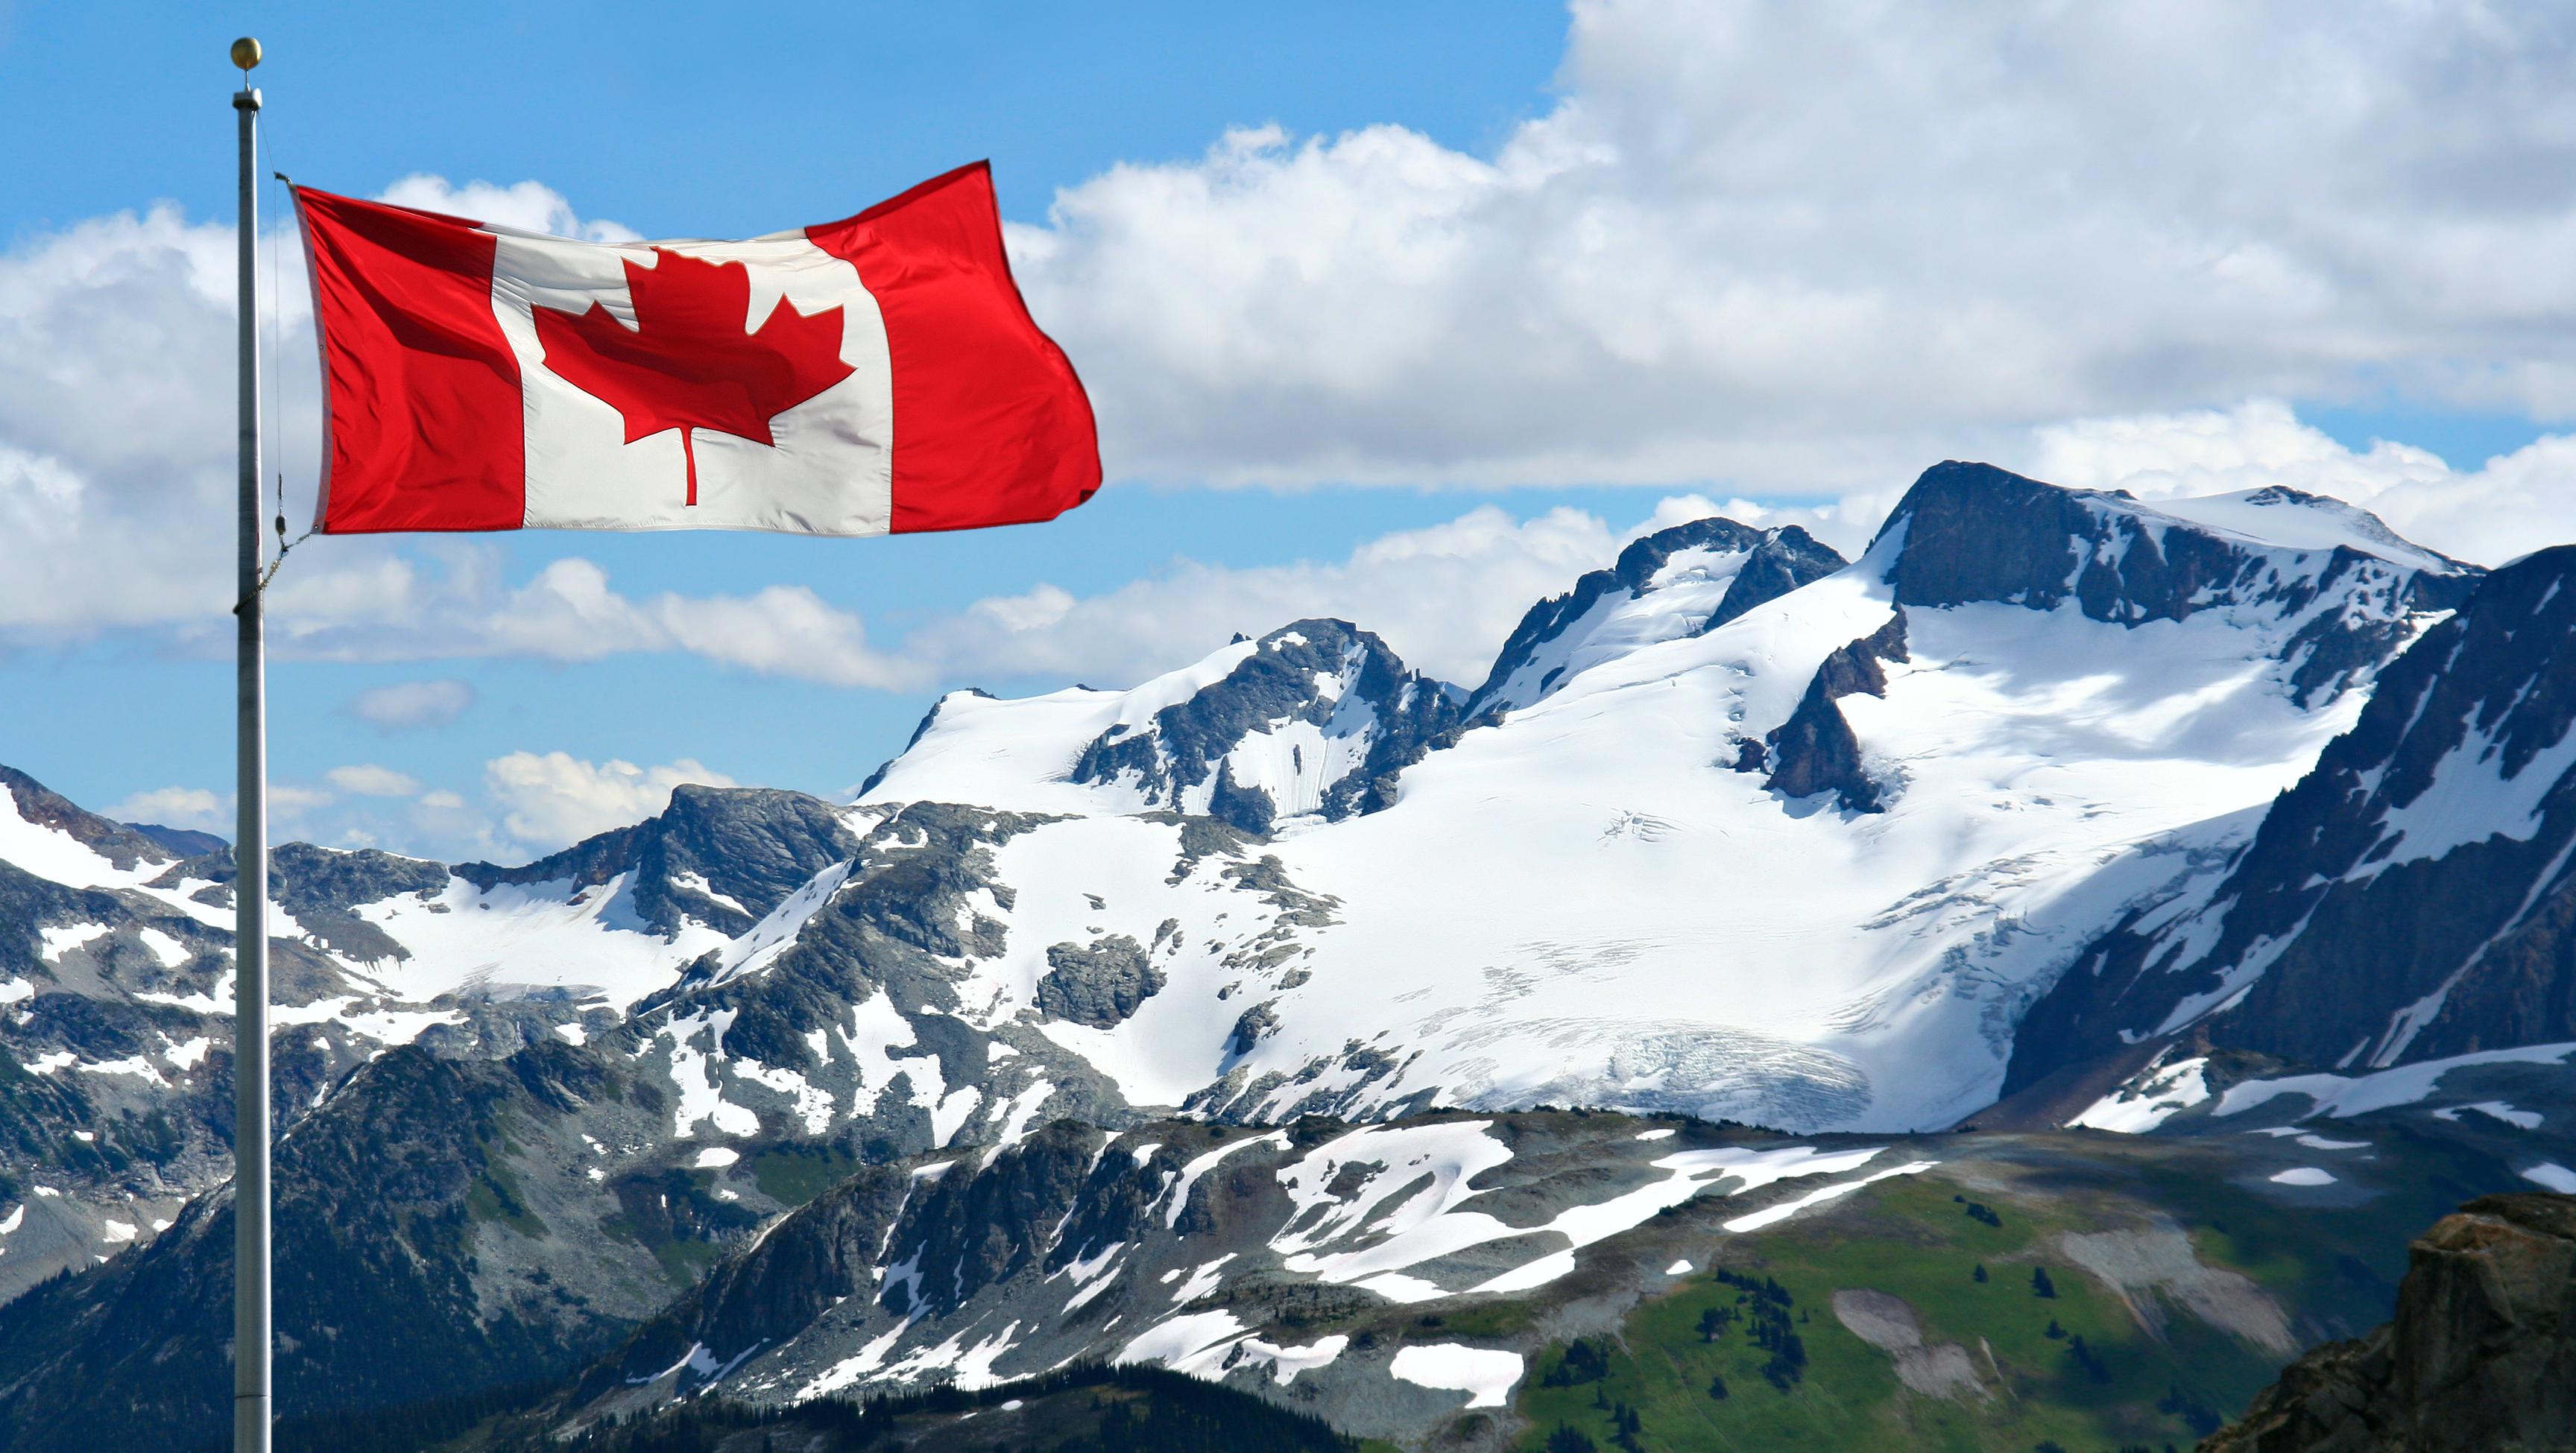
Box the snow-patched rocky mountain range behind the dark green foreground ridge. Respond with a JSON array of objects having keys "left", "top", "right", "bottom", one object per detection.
[{"left": 0, "top": 463, "right": 2576, "bottom": 1448}]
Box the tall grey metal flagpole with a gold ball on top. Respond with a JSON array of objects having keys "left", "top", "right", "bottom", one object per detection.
[{"left": 232, "top": 36, "right": 271, "bottom": 1453}]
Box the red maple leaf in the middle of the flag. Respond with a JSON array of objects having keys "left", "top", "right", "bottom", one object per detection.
[{"left": 536, "top": 247, "right": 853, "bottom": 505}]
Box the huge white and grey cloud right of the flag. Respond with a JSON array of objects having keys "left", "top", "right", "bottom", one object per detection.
[{"left": 1010, "top": 0, "right": 2576, "bottom": 495}]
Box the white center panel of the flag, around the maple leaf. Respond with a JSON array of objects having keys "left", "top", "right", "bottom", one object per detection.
[{"left": 484, "top": 224, "right": 894, "bottom": 536}]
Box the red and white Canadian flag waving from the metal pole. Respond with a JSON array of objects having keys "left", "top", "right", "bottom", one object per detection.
[{"left": 296, "top": 162, "right": 1100, "bottom": 536}]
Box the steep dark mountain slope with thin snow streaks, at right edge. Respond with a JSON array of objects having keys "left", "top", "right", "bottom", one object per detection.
[{"left": 2012, "top": 546, "right": 2576, "bottom": 1087}]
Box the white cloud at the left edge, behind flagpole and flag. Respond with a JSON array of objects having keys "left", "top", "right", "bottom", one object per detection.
[{"left": 0, "top": 178, "right": 626, "bottom": 642}]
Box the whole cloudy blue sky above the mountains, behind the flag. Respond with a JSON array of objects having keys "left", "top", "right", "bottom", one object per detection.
[{"left": 0, "top": 0, "right": 2576, "bottom": 855}]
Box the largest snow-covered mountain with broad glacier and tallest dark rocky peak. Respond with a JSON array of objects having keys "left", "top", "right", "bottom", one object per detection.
[{"left": 824, "top": 466, "right": 2475, "bottom": 1128}]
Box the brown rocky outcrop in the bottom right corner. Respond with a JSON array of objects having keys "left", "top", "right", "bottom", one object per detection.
[{"left": 2200, "top": 1193, "right": 2576, "bottom": 1453}]
